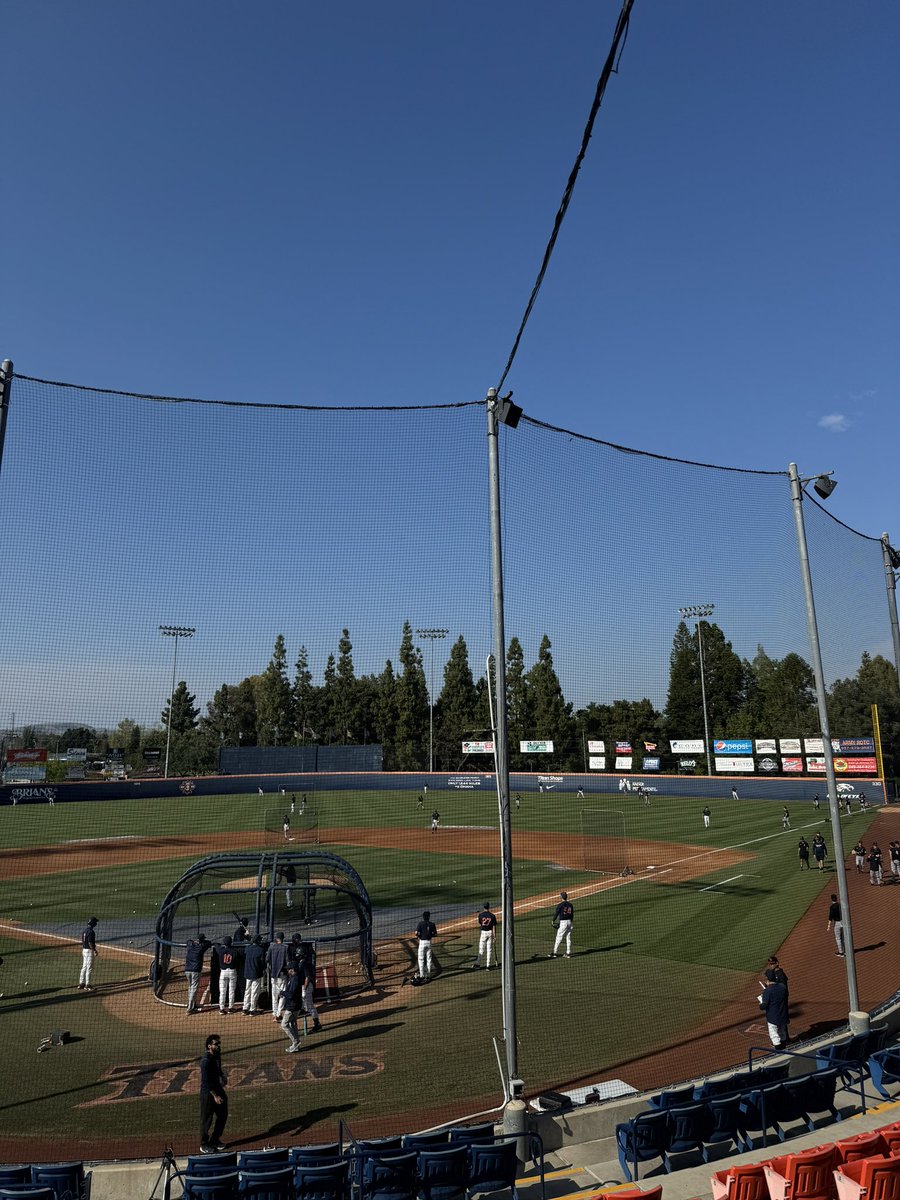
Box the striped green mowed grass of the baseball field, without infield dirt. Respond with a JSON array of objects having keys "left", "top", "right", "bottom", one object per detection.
[{"left": 0, "top": 790, "right": 871, "bottom": 1148}]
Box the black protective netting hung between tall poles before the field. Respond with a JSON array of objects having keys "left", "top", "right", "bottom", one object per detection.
[{"left": 0, "top": 378, "right": 900, "bottom": 1141}]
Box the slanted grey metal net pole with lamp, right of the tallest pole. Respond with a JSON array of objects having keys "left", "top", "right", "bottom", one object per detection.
[{"left": 787, "top": 462, "right": 859, "bottom": 1014}]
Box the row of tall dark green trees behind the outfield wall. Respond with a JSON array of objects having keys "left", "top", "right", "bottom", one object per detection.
[{"left": 28, "top": 622, "right": 900, "bottom": 774}]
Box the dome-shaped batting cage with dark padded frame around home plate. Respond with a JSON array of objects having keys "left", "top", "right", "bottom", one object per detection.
[{"left": 150, "top": 848, "right": 374, "bottom": 1007}]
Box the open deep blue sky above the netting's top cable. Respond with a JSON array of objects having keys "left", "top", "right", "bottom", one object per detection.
[{"left": 0, "top": 0, "right": 900, "bottom": 712}]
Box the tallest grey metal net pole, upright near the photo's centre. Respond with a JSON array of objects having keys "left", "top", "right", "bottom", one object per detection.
[{"left": 487, "top": 388, "right": 518, "bottom": 1099}]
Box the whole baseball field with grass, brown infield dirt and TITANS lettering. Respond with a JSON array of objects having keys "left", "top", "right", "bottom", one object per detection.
[{"left": 0, "top": 790, "right": 893, "bottom": 1162}]
